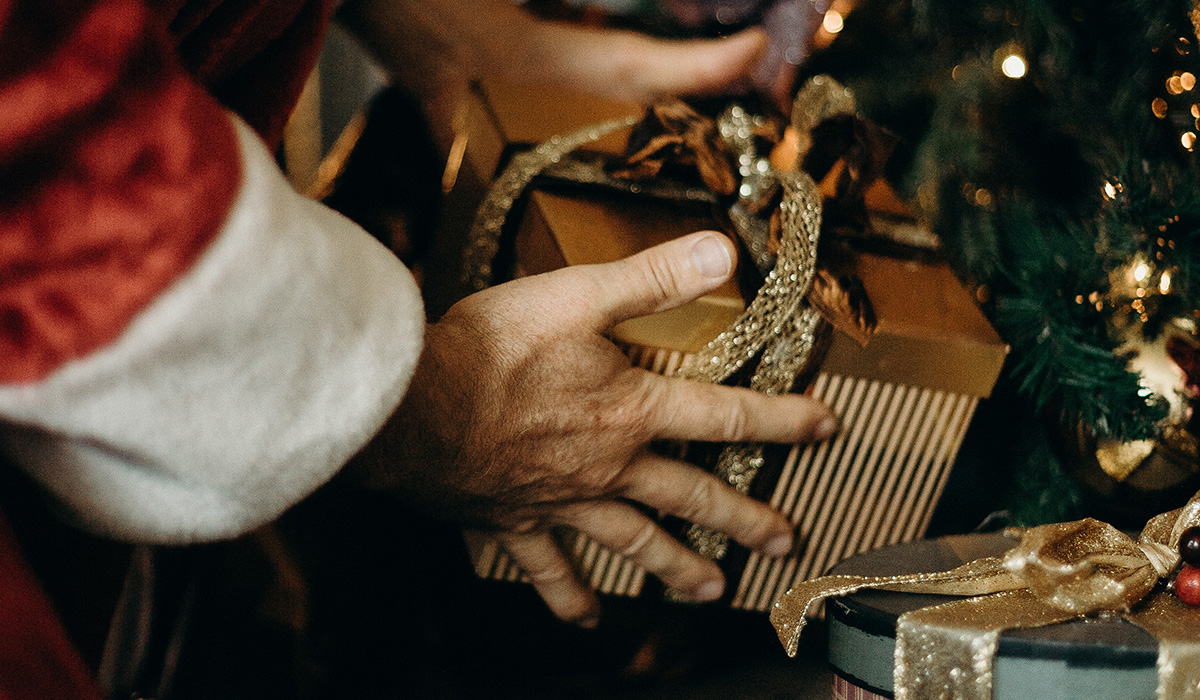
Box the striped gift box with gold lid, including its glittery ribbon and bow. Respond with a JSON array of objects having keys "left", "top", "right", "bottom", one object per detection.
[{"left": 450, "top": 78, "right": 1007, "bottom": 611}]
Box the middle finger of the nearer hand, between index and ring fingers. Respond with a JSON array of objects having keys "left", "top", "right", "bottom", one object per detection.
[{"left": 620, "top": 453, "right": 793, "bottom": 557}]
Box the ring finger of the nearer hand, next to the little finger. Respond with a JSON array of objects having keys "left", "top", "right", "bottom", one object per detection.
[{"left": 560, "top": 501, "right": 725, "bottom": 600}]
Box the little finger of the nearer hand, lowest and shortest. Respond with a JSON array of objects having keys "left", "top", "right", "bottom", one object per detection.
[{"left": 496, "top": 532, "right": 600, "bottom": 628}]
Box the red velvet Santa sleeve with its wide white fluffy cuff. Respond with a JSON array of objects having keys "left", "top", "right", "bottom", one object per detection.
[{"left": 0, "top": 0, "right": 424, "bottom": 543}]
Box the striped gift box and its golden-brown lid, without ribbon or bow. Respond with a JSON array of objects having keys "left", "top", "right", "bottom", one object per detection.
[{"left": 451, "top": 79, "right": 1007, "bottom": 611}]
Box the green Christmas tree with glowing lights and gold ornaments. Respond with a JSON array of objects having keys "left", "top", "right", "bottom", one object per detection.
[{"left": 805, "top": 0, "right": 1200, "bottom": 522}]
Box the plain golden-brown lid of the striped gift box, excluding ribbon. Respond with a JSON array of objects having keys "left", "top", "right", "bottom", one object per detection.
[{"left": 517, "top": 192, "right": 1008, "bottom": 396}]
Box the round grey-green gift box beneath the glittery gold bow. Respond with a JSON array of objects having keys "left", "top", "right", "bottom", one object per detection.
[{"left": 826, "top": 534, "right": 1158, "bottom": 700}]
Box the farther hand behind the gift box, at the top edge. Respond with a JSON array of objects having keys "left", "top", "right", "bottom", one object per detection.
[{"left": 340, "top": 0, "right": 790, "bottom": 145}]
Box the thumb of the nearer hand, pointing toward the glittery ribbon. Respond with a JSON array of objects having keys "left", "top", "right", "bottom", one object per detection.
[{"left": 569, "top": 231, "right": 737, "bottom": 328}]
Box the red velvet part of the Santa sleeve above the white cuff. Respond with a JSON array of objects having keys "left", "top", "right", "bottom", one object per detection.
[{"left": 0, "top": 0, "right": 331, "bottom": 384}]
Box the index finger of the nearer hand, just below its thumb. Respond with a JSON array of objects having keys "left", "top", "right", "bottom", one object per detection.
[{"left": 647, "top": 375, "right": 838, "bottom": 443}]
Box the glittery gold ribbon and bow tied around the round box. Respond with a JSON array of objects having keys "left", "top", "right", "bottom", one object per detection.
[{"left": 770, "top": 493, "right": 1200, "bottom": 700}]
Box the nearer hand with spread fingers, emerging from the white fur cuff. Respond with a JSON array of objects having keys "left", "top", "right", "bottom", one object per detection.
[{"left": 361, "top": 232, "right": 835, "bottom": 624}]
